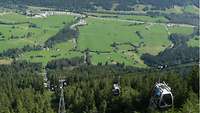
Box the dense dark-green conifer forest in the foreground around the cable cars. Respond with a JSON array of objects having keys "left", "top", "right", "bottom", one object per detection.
[{"left": 0, "top": 59, "right": 199, "bottom": 113}]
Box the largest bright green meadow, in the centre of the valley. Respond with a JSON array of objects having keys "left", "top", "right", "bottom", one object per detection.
[{"left": 78, "top": 18, "right": 171, "bottom": 67}]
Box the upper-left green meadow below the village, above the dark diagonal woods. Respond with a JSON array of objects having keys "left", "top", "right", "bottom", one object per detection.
[{"left": 0, "top": 13, "right": 73, "bottom": 52}]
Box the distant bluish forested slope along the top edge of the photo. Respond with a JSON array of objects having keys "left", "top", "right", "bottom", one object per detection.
[{"left": 0, "top": 0, "right": 199, "bottom": 10}]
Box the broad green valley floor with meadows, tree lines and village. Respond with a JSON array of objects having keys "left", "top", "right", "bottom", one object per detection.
[{"left": 0, "top": 11, "right": 199, "bottom": 67}]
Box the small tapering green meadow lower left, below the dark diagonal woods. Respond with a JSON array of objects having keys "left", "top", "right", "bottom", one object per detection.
[{"left": 19, "top": 40, "right": 82, "bottom": 65}]
